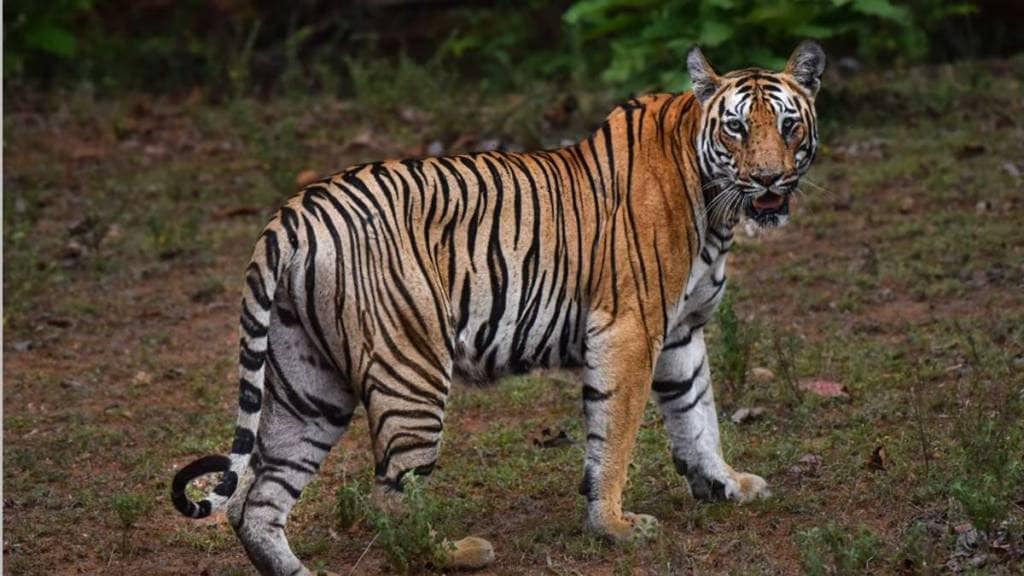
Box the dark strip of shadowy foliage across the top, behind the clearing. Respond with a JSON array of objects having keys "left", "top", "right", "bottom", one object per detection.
[{"left": 4, "top": 0, "right": 1024, "bottom": 97}]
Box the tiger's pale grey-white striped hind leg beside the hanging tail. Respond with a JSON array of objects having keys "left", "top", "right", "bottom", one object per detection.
[{"left": 227, "top": 305, "right": 356, "bottom": 576}]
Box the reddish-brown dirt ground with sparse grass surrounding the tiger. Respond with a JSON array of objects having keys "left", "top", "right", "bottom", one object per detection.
[{"left": 3, "top": 58, "right": 1024, "bottom": 575}]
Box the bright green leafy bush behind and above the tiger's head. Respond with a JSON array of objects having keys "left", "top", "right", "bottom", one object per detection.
[{"left": 564, "top": 0, "right": 972, "bottom": 90}]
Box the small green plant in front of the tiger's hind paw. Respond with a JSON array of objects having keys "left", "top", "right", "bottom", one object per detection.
[{"left": 369, "top": 472, "right": 447, "bottom": 574}]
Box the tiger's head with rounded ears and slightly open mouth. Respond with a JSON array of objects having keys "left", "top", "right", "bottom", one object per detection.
[{"left": 686, "top": 41, "right": 825, "bottom": 228}]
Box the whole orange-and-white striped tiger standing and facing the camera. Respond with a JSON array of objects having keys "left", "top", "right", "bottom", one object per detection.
[{"left": 171, "top": 41, "right": 825, "bottom": 575}]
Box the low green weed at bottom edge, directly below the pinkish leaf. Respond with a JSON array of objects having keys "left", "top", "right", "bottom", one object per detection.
[{"left": 797, "top": 523, "right": 882, "bottom": 576}]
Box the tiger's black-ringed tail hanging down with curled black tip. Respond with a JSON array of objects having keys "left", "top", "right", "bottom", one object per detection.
[{"left": 171, "top": 207, "right": 299, "bottom": 519}]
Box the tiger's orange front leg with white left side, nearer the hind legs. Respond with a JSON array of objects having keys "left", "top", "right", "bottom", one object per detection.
[{"left": 580, "top": 321, "right": 657, "bottom": 542}]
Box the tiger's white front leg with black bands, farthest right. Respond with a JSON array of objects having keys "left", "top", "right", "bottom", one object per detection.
[{"left": 652, "top": 326, "right": 769, "bottom": 502}]
